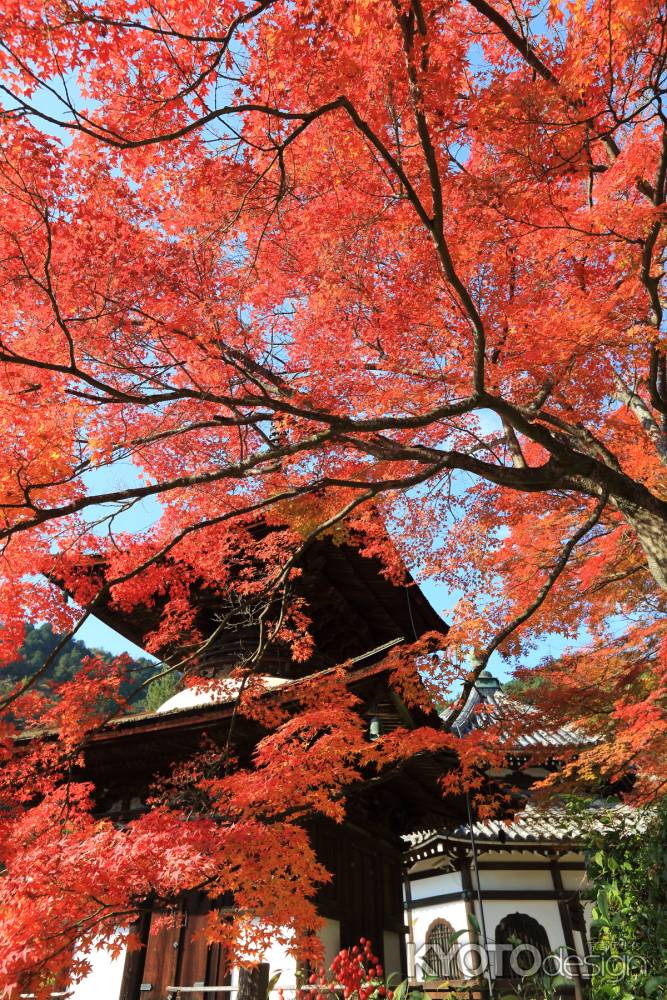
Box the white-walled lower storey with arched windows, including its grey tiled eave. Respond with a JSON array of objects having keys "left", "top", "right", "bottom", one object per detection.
[{"left": 406, "top": 807, "right": 590, "bottom": 997}]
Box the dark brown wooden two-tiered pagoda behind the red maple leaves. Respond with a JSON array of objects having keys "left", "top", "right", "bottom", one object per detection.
[{"left": 54, "top": 539, "right": 464, "bottom": 1000}]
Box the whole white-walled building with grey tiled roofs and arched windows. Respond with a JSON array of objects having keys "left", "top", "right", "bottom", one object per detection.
[{"left": 405, "top": 671, "right": 604, "bottom": 1000}]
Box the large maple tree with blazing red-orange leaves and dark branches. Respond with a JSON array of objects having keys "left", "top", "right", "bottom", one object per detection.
[{"left": 0, "top": 0, "right": 667, "bottom": 990}]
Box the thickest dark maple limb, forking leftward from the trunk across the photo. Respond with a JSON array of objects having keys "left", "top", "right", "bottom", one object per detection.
[{"left": 0, "top": 292, "right": 665, "bottom": 584}]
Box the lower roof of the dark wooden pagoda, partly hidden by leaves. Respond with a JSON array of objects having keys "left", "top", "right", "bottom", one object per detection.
[{"left": 17, "top": 658, "right": 464, "bottom": 837}]
